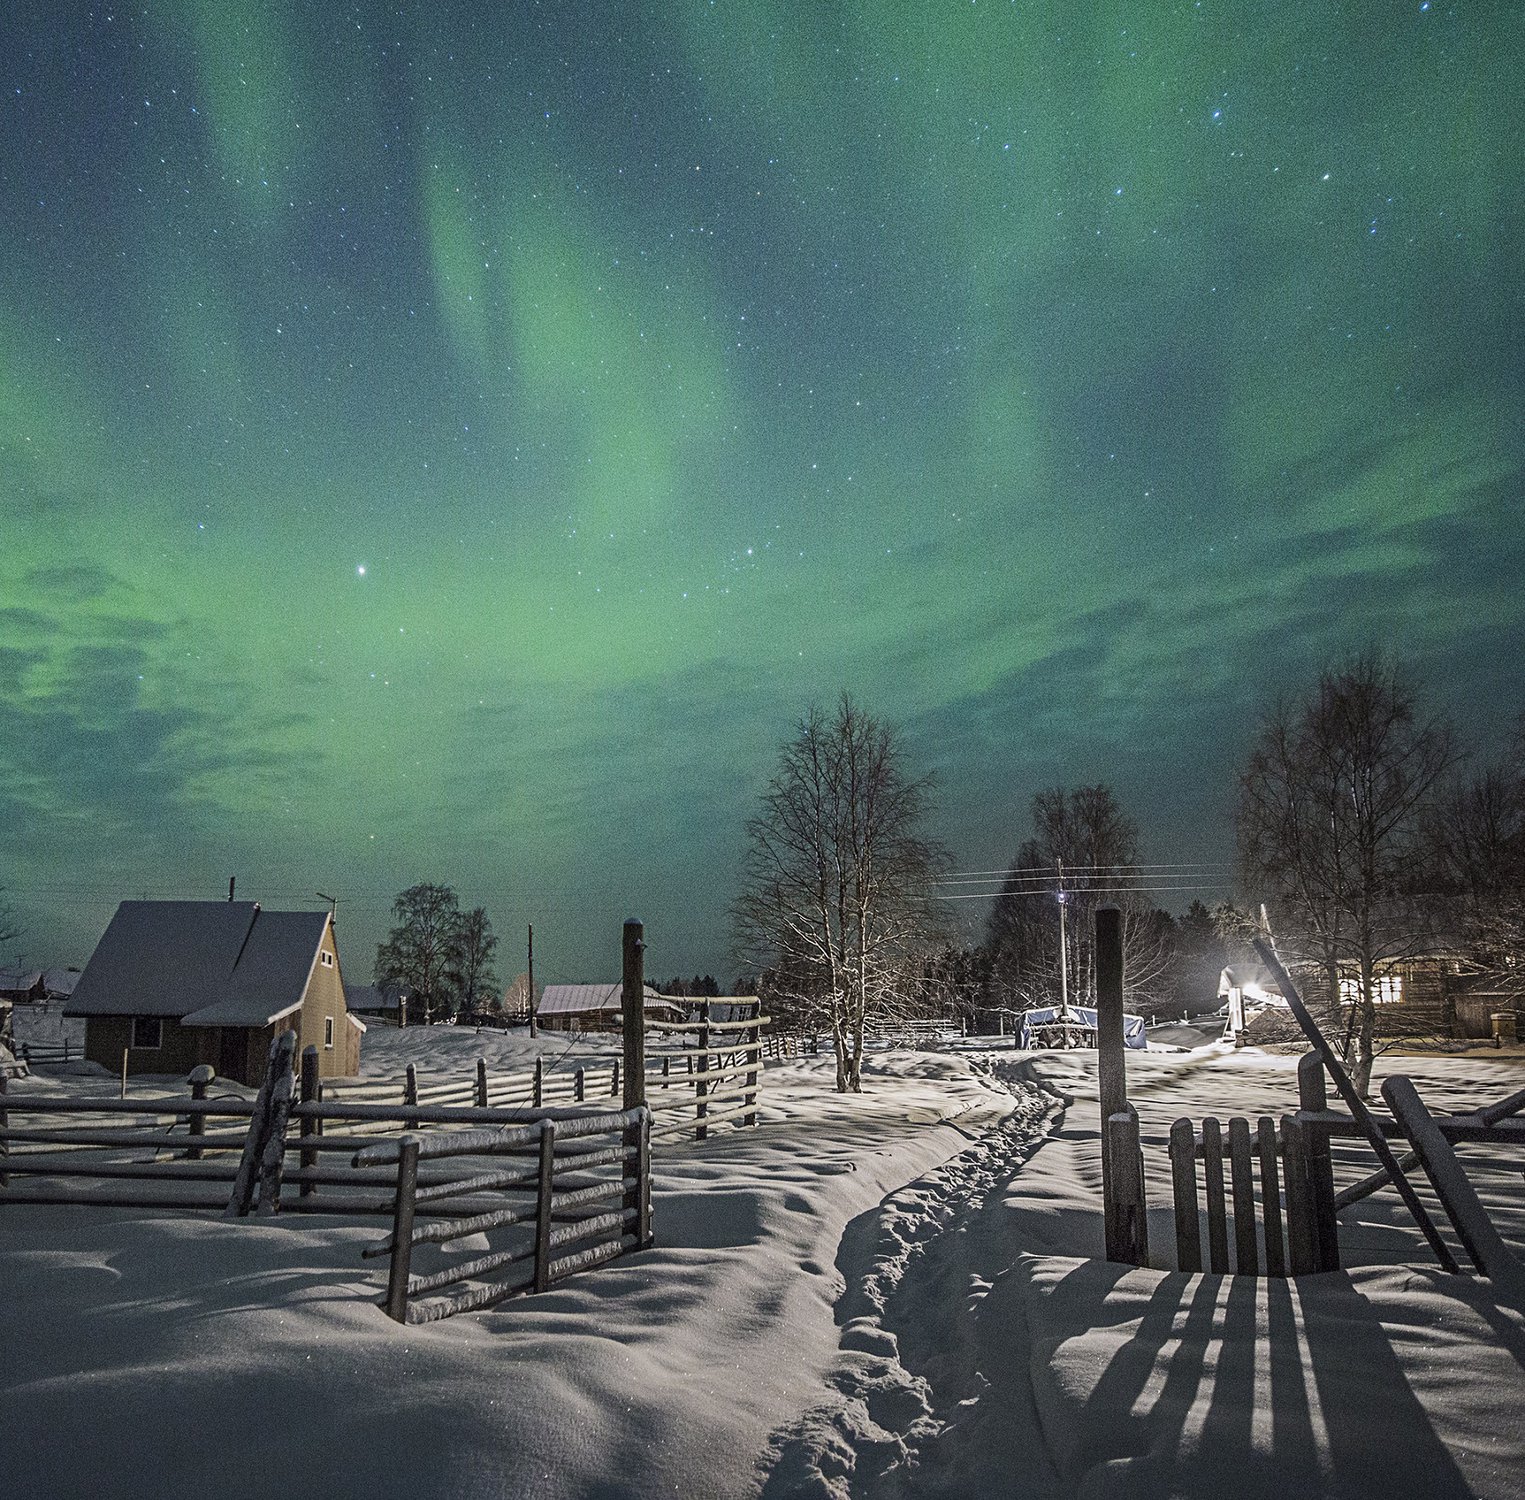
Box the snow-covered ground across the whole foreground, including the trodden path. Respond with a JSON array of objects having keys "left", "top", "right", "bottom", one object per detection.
[{"left": 0, "top": 1027, "right": 1525, "bottom": 1500}]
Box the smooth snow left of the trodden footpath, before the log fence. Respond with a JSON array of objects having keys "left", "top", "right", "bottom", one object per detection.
[{"left": 0, "top": 1029, "right": 1043, "bottom": 1500}]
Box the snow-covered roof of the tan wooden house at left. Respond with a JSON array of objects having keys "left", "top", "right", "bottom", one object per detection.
[{"left": 64, "top": 901, "right": 329, "bottom": 1026}]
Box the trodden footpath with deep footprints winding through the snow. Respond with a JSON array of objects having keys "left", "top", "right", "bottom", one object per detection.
[{"left": 763, "top": 1059, "right": 1068, "bottom": 1500}]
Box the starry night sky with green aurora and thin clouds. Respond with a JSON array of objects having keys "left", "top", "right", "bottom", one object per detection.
[{"left": 0, "top": 0, "right": 1525, "bottom": 982}]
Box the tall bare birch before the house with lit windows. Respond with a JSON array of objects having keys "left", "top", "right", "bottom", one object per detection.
[{"left": 1237, "top": 652, "right": 1455, "bottom": 1093}]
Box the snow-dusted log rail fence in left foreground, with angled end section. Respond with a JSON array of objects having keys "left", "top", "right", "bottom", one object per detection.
[{"left": 0, "top": 1032, "right": 651, "bottom": 1322}]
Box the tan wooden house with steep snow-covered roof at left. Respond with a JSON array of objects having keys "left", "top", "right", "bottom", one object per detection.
[{"left": 64, "top": 901, "right": 364, "bottom": 1084}]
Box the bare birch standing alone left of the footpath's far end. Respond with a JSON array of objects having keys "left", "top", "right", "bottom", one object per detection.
[{"left": 732, "top": 694, "right": 942, "bottom": 1093}]
